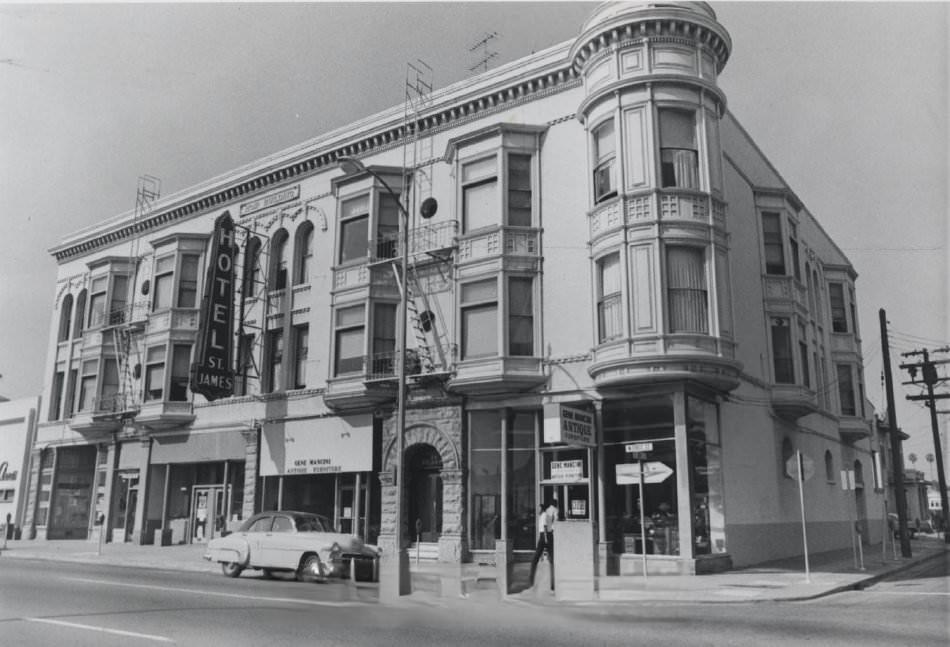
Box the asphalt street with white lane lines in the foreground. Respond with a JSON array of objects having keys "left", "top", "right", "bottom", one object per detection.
[{"left": 0, "top": 554, "right": 950, "bottom": 647}]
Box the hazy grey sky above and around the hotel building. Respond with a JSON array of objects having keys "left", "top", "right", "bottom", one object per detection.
[{"left": 0, "top": 2, "right": 950, "bottom": 464}]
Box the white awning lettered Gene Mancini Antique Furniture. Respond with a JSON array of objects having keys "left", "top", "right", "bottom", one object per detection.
[{"left": 260, "top": 414, "right": 373, "bottom": 476}]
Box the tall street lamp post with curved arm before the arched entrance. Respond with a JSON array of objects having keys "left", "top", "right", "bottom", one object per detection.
[{"left": 338, "top": 157, "right": 418, "bottom": 601}]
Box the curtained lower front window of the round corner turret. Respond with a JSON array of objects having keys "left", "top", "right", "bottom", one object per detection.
[{"left": 666, "top": 246, "right": 709, "bottom": 333}]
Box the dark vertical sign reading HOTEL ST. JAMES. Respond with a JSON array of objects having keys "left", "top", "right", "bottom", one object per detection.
[{"left": 191, "top": 211, "right": 237, "bottom": 400}]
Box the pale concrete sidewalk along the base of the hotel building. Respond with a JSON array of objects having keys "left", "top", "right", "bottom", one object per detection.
[{"left": 0, "top": 535, "right": 950, "bottom": 606}]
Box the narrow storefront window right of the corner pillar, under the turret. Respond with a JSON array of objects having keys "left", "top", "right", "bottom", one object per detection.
[{"left": 686, "top": 397, "right": 726, "bottom": 555}]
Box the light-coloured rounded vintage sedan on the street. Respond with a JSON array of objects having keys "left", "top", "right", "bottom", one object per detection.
[{"left": 204, "top": 510, "right": 378, "bottom": 582}]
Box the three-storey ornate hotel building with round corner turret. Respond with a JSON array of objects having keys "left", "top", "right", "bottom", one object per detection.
[{"left": 27, "top": 3, "right": 883, "bottom": 596}]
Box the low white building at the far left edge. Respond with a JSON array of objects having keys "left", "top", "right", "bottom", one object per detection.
[{"left": 0, "top": 397, "right": 40, "bottom": 539}]
